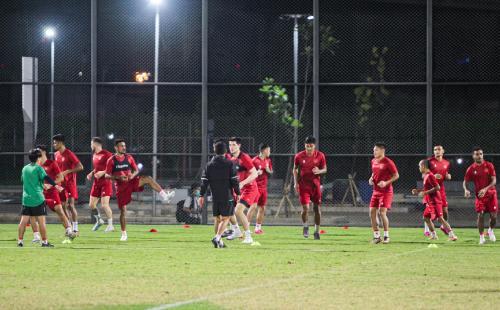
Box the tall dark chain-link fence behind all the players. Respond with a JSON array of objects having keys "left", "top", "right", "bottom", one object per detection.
[{"left": 0, "top": 0, "right": 500, "bottom": 226}]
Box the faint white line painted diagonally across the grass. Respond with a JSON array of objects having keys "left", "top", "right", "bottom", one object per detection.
[{"left": 149, "top": 247, "right": 429, "bottom": 310}]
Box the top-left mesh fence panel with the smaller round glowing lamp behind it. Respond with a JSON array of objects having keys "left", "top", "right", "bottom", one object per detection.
[{"left": 0, "top": 0, "right": 90, "bottom": 82}]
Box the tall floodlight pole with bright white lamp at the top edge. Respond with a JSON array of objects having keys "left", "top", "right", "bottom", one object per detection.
[{"left": 150, "top": 0, "right": 162, "bottom": 216}]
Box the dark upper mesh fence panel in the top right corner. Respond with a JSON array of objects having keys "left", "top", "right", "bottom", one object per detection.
[{"left": 433, "top": 0, "right": 500, "bottom": 81}]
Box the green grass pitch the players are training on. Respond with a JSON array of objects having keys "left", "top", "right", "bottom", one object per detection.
[{"left": 0, "top": 225, "right": 500, "bottom": 309}]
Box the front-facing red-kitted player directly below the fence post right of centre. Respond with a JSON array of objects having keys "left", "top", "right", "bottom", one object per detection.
[{"left": 293, "top": 136, "right": 327, "bottom": 240}]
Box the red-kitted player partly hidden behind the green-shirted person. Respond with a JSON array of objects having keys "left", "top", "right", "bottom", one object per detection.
[{"left": 31, "top": 145, "right": 76, "bottom": 242}]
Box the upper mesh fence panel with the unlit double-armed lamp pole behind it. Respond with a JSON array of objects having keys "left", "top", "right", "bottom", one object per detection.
[{"left": 208, "top": 0, "right": 312, "bottom": 82}]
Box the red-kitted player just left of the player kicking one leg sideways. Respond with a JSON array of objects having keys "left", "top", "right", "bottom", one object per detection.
[{"left": 87, "top": 137, "right": 115, "bottom": 232}]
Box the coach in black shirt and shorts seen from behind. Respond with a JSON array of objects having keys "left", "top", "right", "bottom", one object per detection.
[{"left": 199, "top": 141, "right": 240, "bottom": 248}]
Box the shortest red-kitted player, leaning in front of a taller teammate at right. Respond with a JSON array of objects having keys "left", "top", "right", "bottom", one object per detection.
[{"left": 412, "top": 159, "right": 457, "bottom": 241}]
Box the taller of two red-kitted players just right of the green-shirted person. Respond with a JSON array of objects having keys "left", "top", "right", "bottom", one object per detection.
[{"left": 52, "top": 134, "right": 83, "bottom": 234}]
